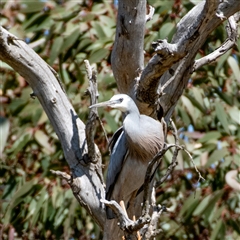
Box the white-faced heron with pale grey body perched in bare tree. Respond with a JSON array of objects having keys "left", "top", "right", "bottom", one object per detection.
[{"left": 90, "top": 94, "right": 165, "bottom": 218}]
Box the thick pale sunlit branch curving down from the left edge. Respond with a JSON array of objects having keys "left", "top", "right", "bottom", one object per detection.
[{"left": 0, "top": 26, "right": 105, "bottom": 228}]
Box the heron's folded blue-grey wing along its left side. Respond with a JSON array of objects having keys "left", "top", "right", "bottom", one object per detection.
[{"left": 106, "top": 129, "right": 128, "bottom": 219}]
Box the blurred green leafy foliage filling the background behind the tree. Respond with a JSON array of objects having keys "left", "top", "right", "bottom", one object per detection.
[{"left": 0, "top": 0, "right": 240, "bottom": 240}]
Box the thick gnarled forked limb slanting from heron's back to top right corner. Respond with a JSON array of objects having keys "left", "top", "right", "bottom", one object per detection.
[{"left": 136, "top": 0, "right": 240, "bottom": 118}]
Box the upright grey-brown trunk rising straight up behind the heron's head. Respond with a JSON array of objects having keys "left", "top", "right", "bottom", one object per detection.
[{"left": 111, "top": 0, "right": 146, "bottom": 97}]
